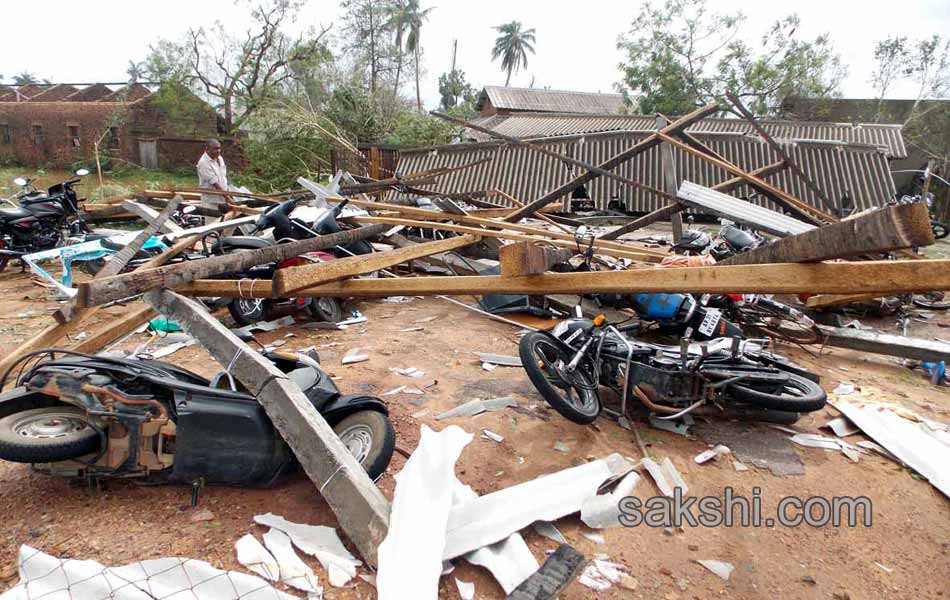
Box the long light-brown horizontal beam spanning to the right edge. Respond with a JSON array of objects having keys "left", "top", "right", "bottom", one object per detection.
[{"left": 180, "top": 259, "right": 950, "bottom": 298}]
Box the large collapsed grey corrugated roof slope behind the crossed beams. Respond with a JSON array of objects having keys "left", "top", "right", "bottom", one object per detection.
[{"left": 391, "top": 132, "right": 895, "bottom": 212}]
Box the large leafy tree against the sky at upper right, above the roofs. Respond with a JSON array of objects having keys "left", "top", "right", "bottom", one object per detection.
[{"left": 618, "top": 0, "right": 845, "bottom": 114}]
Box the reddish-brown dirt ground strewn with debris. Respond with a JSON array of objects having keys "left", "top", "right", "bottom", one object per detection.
[{"left": 0, "top": 260, "right": 950, "bottom": 600}]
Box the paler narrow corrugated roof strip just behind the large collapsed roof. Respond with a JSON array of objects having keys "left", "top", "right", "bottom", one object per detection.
[{"left": 467, "top": 113, "right": 907, "bottom": 158}]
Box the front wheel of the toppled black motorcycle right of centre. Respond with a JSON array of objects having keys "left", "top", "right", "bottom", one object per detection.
[{"left": 518, "top": 331, "right": 601, "bottom": 425}]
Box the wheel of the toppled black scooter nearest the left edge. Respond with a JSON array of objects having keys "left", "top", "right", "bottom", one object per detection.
[{"left": 0, "top": 406, "right": 100, "bottom": 463}]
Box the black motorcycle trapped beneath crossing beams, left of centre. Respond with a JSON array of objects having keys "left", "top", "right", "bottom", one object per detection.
[{"left": 211, "top": 198, "right": 373, "bottom": 325}]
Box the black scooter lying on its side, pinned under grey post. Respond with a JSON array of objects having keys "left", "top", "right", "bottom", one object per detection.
[{"left": 0, "top": 340, "right": 395, "bottom": 485}]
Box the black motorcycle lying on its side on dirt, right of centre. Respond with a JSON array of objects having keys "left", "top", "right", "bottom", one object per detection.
[{"left": 519, "top": 307, "right": 827, "bottom": 424}]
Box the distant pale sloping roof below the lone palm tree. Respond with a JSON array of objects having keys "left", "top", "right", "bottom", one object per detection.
[{"left": 478, "top": 85, "right": 623, "bottom": 114}]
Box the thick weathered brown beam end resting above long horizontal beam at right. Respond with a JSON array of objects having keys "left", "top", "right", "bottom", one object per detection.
[{"left": 719, "top": 204, "right": 934, "bottom": 265}]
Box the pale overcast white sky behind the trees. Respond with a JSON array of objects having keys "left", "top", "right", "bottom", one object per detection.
[{"left": 0, "top": 0, "right": 950, "bottom": 108}]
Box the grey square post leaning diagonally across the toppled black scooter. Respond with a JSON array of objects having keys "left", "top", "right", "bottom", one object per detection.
[{"left": 145, "top": 289, "right": 390, "bottom": 566}]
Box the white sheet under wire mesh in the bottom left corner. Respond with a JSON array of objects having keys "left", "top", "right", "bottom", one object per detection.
[{"left": 0, "top": 545, "right": 297, "bottom": 600}]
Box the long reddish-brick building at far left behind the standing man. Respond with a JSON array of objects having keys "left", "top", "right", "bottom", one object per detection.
[{"left": 0, "top": 83, "right": 243, "bottom": 169}]
